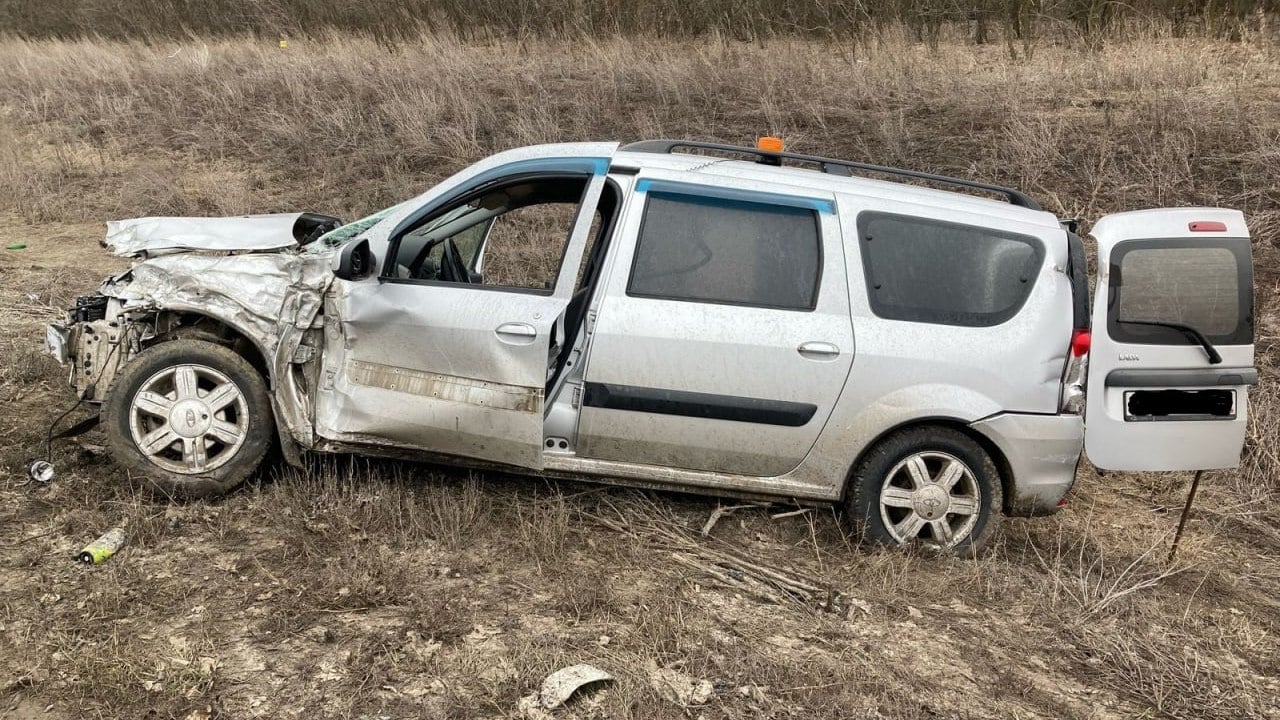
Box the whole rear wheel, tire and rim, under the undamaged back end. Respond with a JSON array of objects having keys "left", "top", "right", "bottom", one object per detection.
[{"left": 846, "top": 425, "right": 1004, "bottom": 555}]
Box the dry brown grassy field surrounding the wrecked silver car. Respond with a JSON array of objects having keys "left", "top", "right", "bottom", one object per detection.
[{"left": 0, "top": 32, "right": 1280, "bottom": 720}]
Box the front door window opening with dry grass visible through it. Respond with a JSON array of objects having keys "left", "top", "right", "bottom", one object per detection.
[{"left": 392, "top": 176, "right": 590, "bottom": 291}]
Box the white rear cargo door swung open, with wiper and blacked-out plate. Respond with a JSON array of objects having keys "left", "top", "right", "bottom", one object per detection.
[{"left": 1085, "top": 208, "right": 1258, "bottom": 470}]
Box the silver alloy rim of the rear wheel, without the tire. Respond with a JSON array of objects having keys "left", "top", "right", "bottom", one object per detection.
[{"left": 879, "top": 451, "right": 982, "bottom": 547}]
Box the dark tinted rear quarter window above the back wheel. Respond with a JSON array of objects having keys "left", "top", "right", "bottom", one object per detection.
[{"left": 858, "top": 213, "right": 1044, "bottom": 328}]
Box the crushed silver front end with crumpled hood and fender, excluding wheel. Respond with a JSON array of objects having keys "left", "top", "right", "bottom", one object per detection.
[{"left": 45, "top": 214, "right": 337, "bottom": 454}]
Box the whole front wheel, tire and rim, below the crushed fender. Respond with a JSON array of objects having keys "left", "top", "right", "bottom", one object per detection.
[{"left": 102, "top": 340, "right": 275, "bottom": 498}]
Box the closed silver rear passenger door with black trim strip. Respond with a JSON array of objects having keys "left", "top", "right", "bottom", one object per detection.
[{"left": 577, "top": 170, "right": 854, "bottom": 477}]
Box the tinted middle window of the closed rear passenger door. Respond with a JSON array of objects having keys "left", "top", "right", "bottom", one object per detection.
[{"left": 627, "top": 192, "right": 822, "bottom": 310}]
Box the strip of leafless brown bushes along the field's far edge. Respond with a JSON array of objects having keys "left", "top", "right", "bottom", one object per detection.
[{"left": 0, "top": 0, "right": 1274, "bottom": 44}]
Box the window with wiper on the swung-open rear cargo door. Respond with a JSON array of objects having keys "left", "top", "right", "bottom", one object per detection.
[{"left": 1107, "top": 238, "right": 1253, "bottom": 345}]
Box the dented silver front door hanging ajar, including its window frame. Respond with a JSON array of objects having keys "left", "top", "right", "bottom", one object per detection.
[{"left": 316, "top": 159, "right": 604, "bottom": 469}]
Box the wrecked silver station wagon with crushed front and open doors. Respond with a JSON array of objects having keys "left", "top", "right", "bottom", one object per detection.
[{"left": 46, "top": 138, "right": 1257, "bottom": 552}]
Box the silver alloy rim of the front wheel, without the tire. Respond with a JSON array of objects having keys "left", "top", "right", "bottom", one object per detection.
[{"left": 129, "top": 364, "right": 248, "bottom": 475}]
